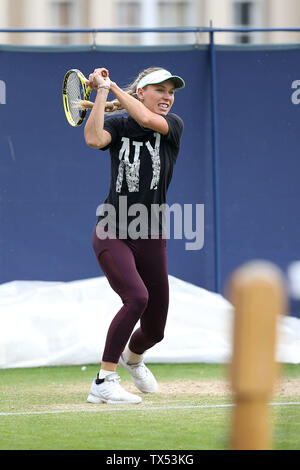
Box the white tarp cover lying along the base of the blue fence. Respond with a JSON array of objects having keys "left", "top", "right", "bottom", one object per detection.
[{"left": 0, "top": 276, "right": 300, "bottom": 368}]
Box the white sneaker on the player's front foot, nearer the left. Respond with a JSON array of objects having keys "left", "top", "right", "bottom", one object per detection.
[{"left": 87, "top": 372, "right": 142, "bottom": 405}]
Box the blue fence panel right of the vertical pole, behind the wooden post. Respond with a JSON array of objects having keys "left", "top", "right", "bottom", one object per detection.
[{"left": 217, "top": 46, "right": 300, "bottom": 294}]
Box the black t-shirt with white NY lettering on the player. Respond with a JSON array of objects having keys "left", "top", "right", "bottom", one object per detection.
[{"left": 98, "top": 113, "right": 183, "bottom": 238}]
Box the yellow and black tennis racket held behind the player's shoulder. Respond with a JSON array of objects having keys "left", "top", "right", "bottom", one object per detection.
[{"left": 62, "top": 69, "right": 108, "bottom": 127}]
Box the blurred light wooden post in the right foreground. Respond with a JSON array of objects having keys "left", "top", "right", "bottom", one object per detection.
[{"left": 227, "top": 261, "right": 286, "bottom": 450}]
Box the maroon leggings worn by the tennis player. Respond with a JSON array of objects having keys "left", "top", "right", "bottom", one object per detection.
[{"left": 93, "top": 228, "right": 169, "bottom": 363}]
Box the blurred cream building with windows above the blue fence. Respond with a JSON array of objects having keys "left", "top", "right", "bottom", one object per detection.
[{"left": 0, "top": 0, "right": 300, "bottom": 45}]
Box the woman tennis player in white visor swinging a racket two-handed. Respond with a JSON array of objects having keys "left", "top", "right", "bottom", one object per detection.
[{"left": 84, "top": 68, "right": 185, "bottom": 404}]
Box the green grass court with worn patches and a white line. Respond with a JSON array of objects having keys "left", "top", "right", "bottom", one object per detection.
[{"left": 0, "top": 364, "right": 300, "bottom": 451}]
